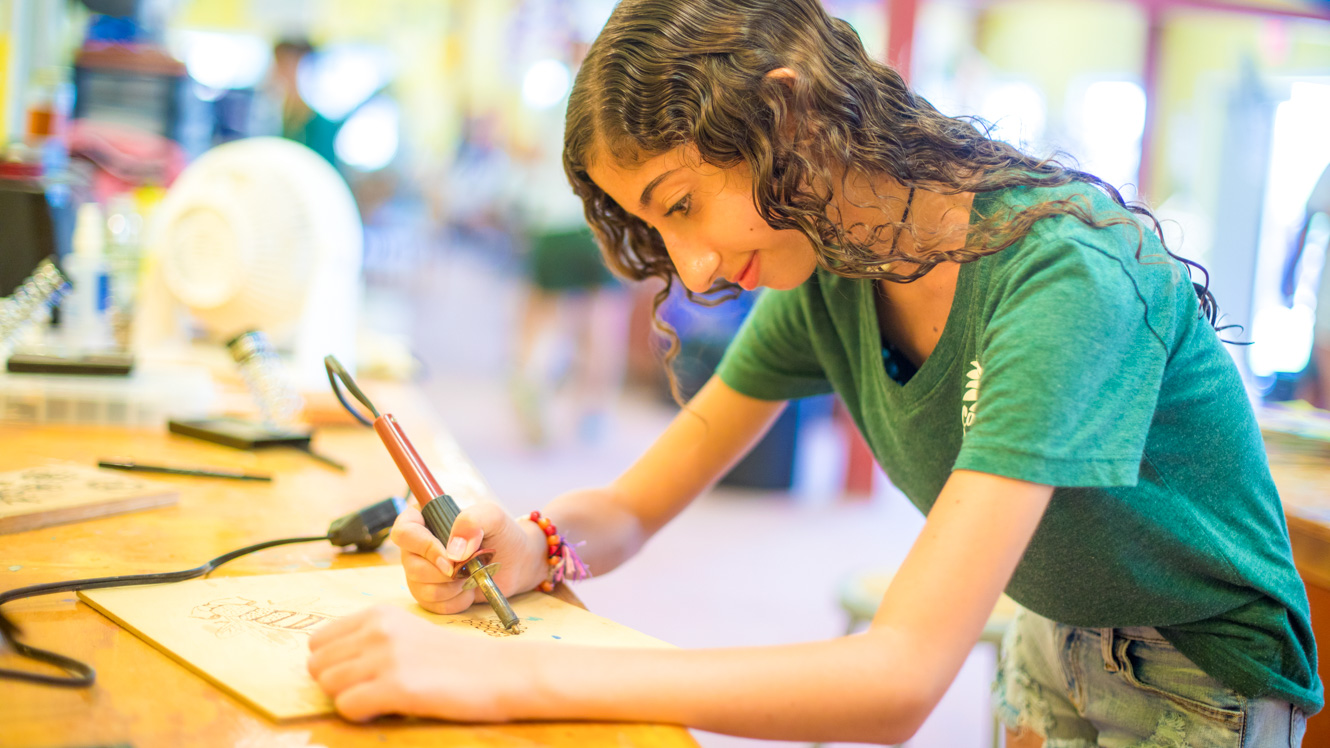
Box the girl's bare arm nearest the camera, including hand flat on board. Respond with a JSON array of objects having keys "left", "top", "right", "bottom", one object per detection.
[{"left": 310, "top": 471, "right": 1052, "bottom": 743}]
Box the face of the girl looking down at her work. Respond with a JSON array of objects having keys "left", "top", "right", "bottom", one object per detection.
[{"left": 588, "top": 145, "right": 818, "bottom": 293}]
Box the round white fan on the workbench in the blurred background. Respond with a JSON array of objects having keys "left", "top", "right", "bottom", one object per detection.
[{"left": 134, "top": 137, "right": 363, "bottom": 382}]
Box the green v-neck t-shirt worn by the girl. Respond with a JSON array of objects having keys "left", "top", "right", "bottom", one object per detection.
[{"left": 718, "top": 184, "right": 1323, "bottom": 713}]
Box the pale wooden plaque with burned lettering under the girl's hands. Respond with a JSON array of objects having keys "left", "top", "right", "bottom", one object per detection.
[{"left": 78, "top": 566, "right": 669, "bottom": 720}]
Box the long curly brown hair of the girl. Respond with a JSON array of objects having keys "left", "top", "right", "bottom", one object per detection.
[{"left": 564, "top": 0, "right": 1217, "bottom": 399}]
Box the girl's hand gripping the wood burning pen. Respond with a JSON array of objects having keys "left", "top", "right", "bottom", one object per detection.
[{"left": 391, "top": 502, "right": 545, "bottom": 614}]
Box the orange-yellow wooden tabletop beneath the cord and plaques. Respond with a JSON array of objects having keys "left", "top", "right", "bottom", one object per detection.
[{"left": 0, "top": 398, "right": 697, "bottom": 748}]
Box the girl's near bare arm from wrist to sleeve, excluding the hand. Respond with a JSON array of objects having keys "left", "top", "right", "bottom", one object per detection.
[{"left": 519, "top": 471, "right": 1052, "bottom": 743}]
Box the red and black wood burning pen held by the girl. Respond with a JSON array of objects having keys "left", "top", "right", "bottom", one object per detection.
[{"left": 323, "top": 355, "right": 520, "bottom": 631}]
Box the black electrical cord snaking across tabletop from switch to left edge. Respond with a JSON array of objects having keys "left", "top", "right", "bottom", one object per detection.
[{"left": 0, "top": 534, "right": 333, "bottom": 688}]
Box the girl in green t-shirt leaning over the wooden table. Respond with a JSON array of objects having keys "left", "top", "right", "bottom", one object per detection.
[{"left": 310, "top": 0, "right": 1322, "bottom": 748}]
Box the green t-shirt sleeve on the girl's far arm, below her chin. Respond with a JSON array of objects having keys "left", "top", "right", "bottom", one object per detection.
[{"left": 717, "top": 283, "right": 831, "bottom": 401}]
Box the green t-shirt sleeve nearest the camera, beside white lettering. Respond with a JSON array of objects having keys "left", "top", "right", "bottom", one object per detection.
[{"left": 955, "top": 232, "right": 1175, "bottom": 487}]
